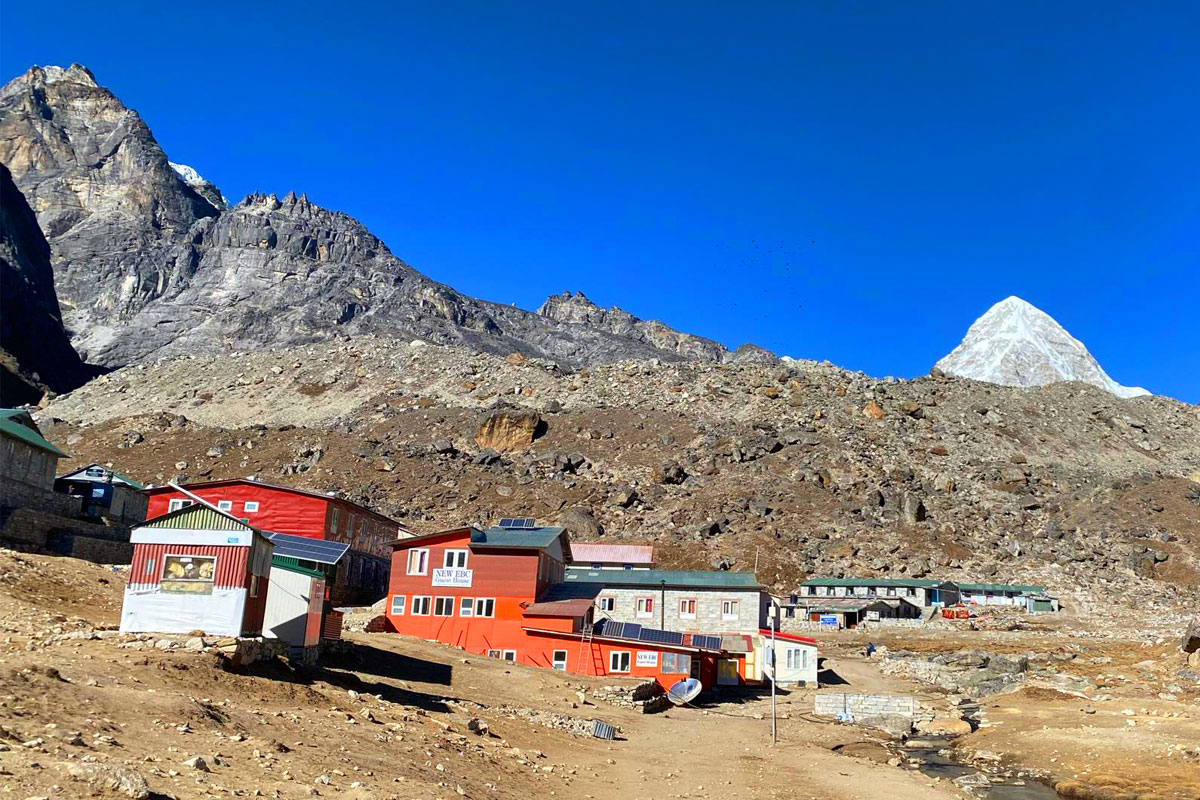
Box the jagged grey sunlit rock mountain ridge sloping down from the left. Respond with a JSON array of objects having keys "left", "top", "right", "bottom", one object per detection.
[{"left": 0, "top": 65, "right": 769, "bottom": 366}]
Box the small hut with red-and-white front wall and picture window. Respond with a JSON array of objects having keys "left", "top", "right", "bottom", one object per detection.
[{"left": 121, "top": 506, "right": 275, "bottom": 636}]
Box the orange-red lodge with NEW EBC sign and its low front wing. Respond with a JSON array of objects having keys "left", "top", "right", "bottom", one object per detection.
[{"left": 386, "top": 528, "right": 721, "bottom": 687}]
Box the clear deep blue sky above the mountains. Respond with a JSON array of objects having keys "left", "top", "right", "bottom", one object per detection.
[{"left": 0, "top": 0, "right": 1200, "bottom": 402}]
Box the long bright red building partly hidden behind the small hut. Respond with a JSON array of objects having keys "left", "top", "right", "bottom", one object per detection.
[{"left": 145, "top": 479, "right": 408, "bottom": 606}]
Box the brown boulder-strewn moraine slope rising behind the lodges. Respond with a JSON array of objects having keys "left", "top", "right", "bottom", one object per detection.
[{"left": 37, "top": 337, "right": 1200, "bottom": 613}]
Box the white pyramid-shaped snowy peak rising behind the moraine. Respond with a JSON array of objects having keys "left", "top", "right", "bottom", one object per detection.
[{"left": 937, "top": 297, "right": 1150, "bottom": 397}]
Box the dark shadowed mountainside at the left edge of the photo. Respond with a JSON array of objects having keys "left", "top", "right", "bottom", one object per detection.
[{"left": 0, "top": 164, "right": 90, "bottom": 405}]
